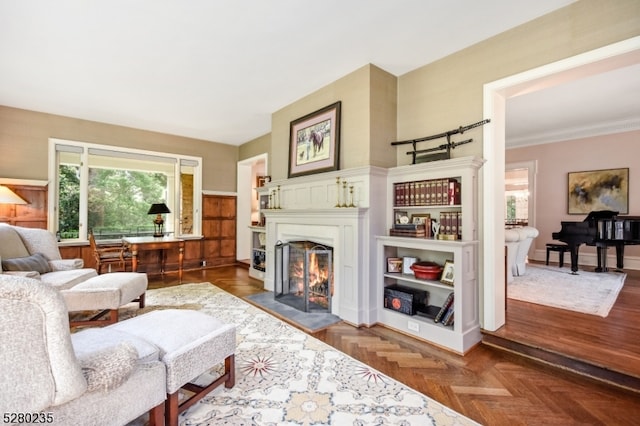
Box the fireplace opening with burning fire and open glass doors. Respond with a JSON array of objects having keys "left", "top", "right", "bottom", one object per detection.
[{"left": 274, "top": 241, "right": 333, "bottom": 312}]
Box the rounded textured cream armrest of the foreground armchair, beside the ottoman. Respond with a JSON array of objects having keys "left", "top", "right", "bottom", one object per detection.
[{"left": 79, "top": 342, "right": 138, "bottom": 392}]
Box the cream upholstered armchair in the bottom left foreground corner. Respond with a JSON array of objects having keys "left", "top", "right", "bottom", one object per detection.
[{"left": 0, "top": 274, "right": 166, "bottom": 426}]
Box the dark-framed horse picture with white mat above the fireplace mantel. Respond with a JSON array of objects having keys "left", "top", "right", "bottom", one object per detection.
[{"left": 289, "top": 101, "right": 341, "bottom": 178}]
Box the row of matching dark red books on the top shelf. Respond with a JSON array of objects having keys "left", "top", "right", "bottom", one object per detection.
[{"left": 393, "top": 178, "right": 461, "bottom": 207}]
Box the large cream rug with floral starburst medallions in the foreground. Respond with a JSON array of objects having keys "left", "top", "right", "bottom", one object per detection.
[{"left": 122, "top": 283, "right": 477, "bottom": 426}]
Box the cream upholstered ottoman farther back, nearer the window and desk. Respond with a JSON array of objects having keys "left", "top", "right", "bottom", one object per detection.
[{"left": 60, "top": 272, "right": 148, "bottom": 327}]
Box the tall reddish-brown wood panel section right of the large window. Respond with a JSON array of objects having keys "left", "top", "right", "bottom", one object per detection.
[{"left": 202, "top": 195, "right": 236, "bottom": 266}]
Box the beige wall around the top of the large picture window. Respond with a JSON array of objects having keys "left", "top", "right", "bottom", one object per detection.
[{"left": 0, "top": 106, "right": 238, "bottom": 192}]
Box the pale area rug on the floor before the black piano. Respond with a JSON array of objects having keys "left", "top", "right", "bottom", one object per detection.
[{"left": 507, "top": 264, "right": 627, "bottom": 317}]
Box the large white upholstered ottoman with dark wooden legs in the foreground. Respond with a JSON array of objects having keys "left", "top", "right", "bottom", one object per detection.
[{"left": 107, "top": 309, "right": 236, "bottom": 426}]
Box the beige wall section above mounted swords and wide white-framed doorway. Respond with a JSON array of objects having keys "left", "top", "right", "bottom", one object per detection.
[{"left": 398, "top": 0, "right": 640, "bottom": 165}]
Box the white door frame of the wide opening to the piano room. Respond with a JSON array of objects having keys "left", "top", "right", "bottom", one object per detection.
[{"left": 481, "top": 37, "right": 640, "bottom": 331}]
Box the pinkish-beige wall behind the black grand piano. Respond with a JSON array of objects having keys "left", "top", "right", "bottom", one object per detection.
[{"left": 505, "top": 131, "right": 640, "bottom": 256}]
